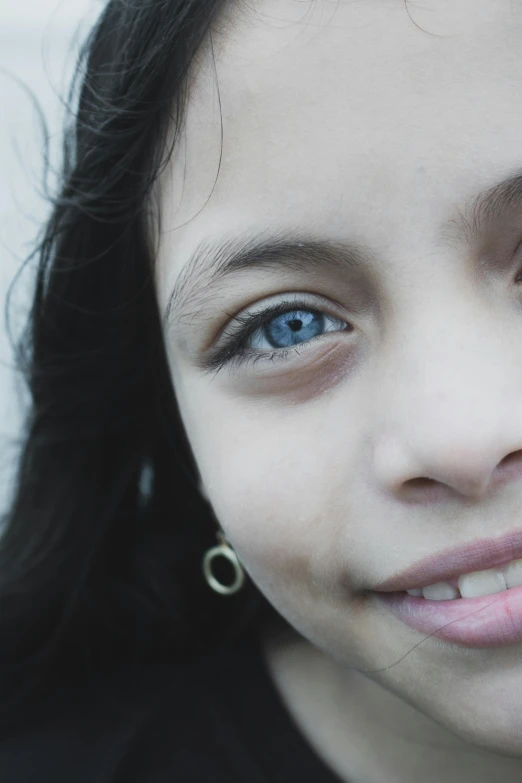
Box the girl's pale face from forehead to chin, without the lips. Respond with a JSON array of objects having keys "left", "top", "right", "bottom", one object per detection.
[{"left": 157, "top": 0, "right": 522, "bottom": 756}]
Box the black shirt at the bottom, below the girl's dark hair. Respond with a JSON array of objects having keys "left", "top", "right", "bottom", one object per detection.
[{"left": 0, "top": 631, "right": 340, "bottom": 783}]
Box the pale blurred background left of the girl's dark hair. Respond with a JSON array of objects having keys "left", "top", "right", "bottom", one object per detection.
[{"left": 0, "top": 0, "right": 104, "bottom": 514}]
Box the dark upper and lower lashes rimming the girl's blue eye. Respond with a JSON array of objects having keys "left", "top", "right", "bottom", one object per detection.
[{"left": 205, "top": 299, "right": 352, "bottom": 372}]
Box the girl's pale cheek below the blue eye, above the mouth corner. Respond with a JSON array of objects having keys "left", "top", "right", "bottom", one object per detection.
[{"left": 175, "top": 378, "right": 354, "bottom": 608}]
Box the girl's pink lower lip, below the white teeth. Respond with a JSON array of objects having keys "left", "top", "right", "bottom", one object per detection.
[{"left": 374, "top": 585, "right": 522, "bottom": 647}]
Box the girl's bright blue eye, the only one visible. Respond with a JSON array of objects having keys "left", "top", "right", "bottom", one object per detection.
[{"left": 205, "top": 300, "right": 353, "bottom": 371}]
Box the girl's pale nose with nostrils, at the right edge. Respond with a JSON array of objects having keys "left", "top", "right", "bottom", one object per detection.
[{"left": 373, "top": 310, "right": 522, "bottom": 501}]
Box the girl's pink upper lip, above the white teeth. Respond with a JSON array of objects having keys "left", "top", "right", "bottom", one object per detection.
[{"left": 373, "top": 530, "right": 522, "bottom": 593}]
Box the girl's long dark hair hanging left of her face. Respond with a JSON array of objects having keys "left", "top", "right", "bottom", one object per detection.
[{"left": 0, "top": 0, "right": 275, "bottom": 724}]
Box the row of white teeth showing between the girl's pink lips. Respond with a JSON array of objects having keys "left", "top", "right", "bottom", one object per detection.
[{"left": 406, "top": 559, "right": 522, "bottom": 601}]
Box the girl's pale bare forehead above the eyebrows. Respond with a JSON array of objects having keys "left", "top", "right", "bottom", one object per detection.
[{"left": 152, "top": 0, "right": 522, "bottom": 298}]
